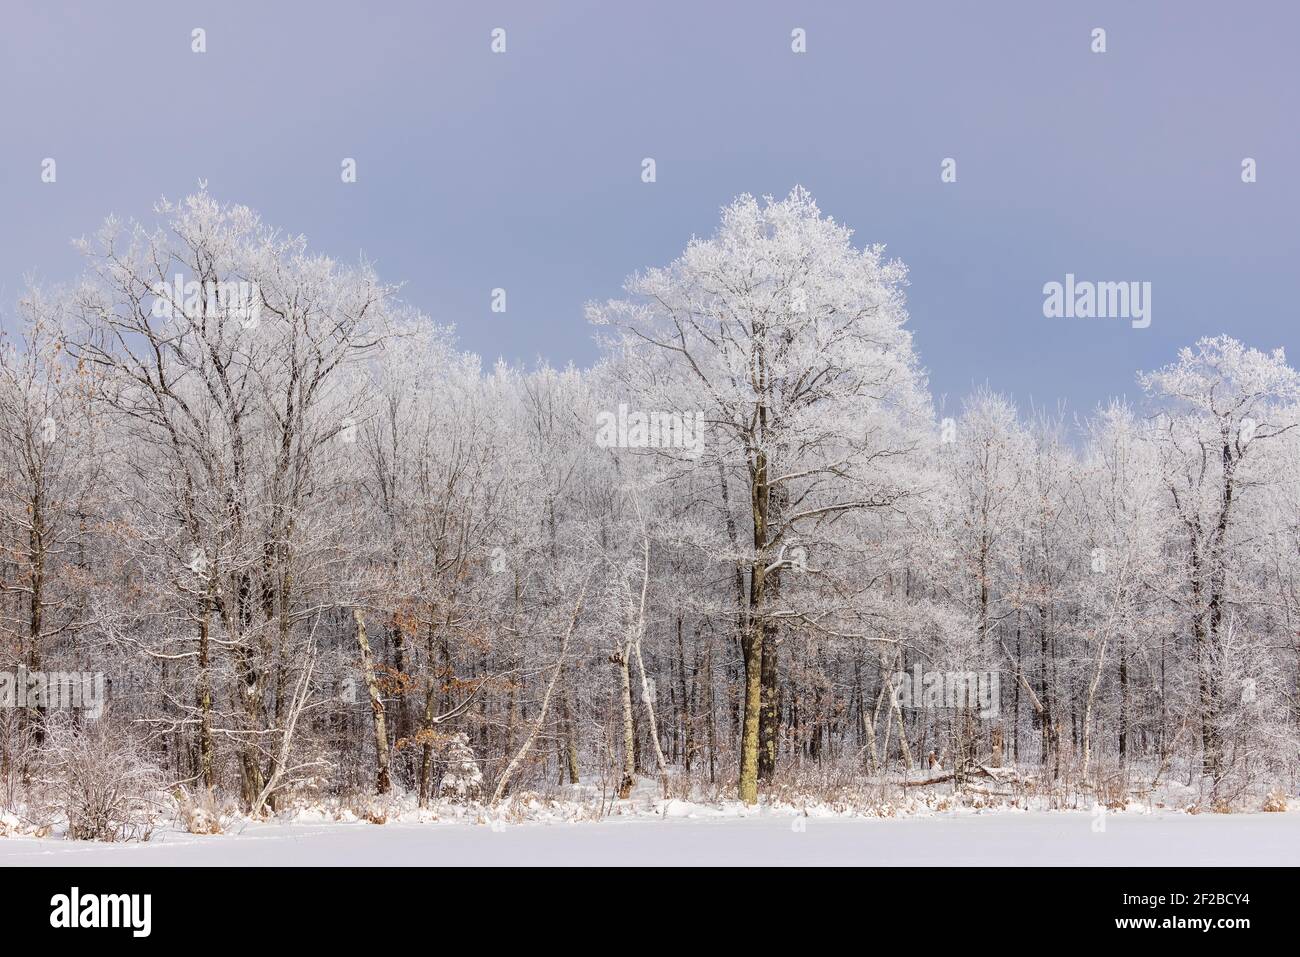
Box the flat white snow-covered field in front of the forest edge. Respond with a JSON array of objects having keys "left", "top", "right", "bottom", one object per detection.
[{"left": 0, "top": 811, "right": 1300, "bottom": 866}]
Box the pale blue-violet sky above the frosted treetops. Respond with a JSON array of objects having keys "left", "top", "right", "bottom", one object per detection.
[{"left": 0, "top": 0, "right": 1300, "bottom": 412}]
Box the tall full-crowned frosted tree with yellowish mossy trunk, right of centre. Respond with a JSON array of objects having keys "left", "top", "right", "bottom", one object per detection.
[{"left": 589, "top": 189, "right": 931, "bottom": 802}]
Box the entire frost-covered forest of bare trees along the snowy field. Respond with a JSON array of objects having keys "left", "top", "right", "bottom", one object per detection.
[{"left": 0, "top": 189, "right": 1300, "bottom": 840}]
